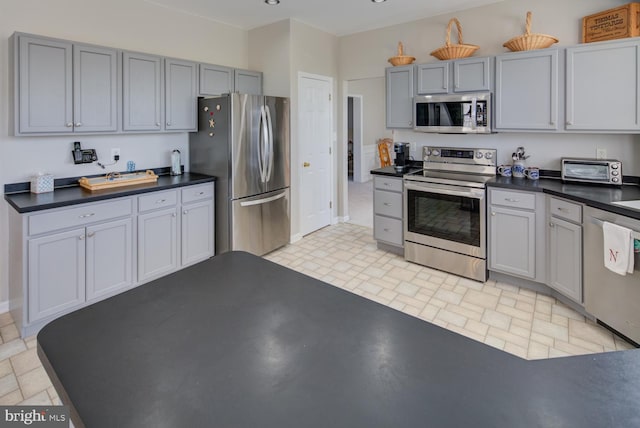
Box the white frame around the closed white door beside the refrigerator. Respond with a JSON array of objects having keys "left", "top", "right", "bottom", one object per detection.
[{"left": 292, "top": 71, "right": 336, "bottom": 237}]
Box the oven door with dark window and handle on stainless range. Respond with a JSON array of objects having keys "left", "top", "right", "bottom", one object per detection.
[{"left": 403, "top": 180, "right": 486, "bottom": 259}]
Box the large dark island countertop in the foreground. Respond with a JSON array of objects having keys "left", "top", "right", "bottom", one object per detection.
[{"left": 37, "top": 253, "right": 640, "bottom": 428}]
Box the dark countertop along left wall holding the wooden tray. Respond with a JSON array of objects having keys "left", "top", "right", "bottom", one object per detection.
[{"left": 4, "top": 172, "right": 216, "bottom": 213}]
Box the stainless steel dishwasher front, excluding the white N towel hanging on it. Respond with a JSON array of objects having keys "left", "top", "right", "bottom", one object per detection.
[{"left": 584, "top": 207, "right": 640, "bottom": 344}]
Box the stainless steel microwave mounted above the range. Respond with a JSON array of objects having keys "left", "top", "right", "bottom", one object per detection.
[{"left": 413, "top": 92, "right": 491, "bottom": 134}]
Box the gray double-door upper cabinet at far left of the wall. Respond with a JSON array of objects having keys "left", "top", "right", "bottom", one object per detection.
[{"left": 13, "top": 33, "right": 118, "bottom": 135}]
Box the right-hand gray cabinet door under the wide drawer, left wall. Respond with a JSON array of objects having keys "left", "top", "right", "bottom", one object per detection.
[{"left": 86, "top": 218, "right": 133, "bottom": 301}]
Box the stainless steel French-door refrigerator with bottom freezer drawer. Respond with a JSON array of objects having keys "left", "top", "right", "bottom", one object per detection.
[{"left": 189, "top": 93, "right": 291, "bottom": 255}]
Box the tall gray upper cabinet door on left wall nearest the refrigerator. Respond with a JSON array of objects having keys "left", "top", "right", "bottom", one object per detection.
[{"left": 165, "top": 59, "right": 198, "bottom": 131}]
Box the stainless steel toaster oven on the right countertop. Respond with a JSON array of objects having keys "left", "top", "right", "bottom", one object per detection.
[{"left": 561, "top": 158, "right": 622, "bottom": 185}]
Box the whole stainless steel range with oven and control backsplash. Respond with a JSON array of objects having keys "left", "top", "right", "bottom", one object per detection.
[{"left": 404, "top": 147, "right": 496, "bottom": 282}]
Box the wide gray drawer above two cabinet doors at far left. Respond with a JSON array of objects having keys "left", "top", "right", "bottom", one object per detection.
[{"left": 29, "top": 198, "right": 133, "bottom": 235}]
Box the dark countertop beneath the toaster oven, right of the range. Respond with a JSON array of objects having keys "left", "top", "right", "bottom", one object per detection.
[{"left": 487, "top": 176, "right": 640, "bottom": 219}]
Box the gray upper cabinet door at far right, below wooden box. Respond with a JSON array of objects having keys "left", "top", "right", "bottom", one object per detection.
[{"left": 566, "top": 39, "right": 640, "bottom": 132}]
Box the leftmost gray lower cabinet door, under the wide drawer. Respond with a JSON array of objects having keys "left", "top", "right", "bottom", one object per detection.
[{"left": 28, "top": 228, "right": 85, "bottom": 322}]
